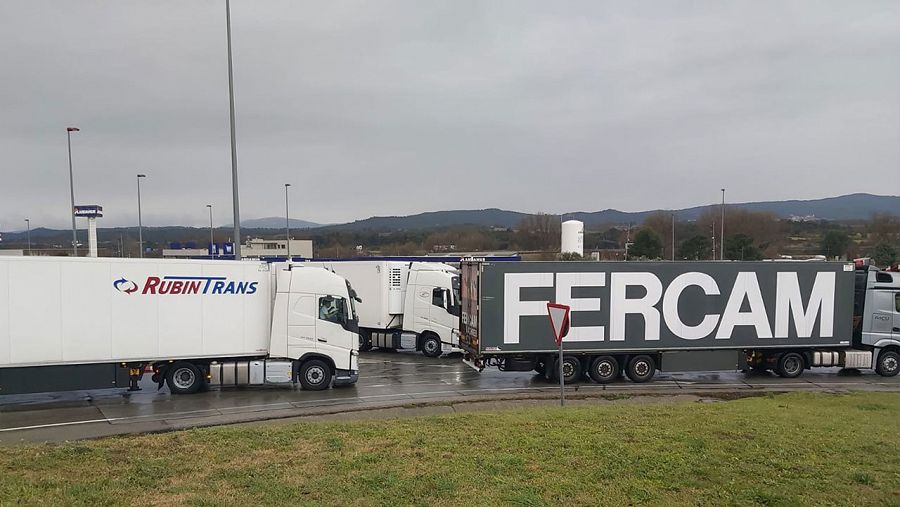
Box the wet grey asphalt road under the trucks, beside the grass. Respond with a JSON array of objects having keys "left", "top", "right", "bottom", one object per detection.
[{"left": 0, "top": 351, "right": 900, "bottom": 443}]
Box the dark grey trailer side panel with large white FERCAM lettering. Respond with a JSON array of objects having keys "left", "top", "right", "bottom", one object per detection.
[{"left": 462, "top": 262, "right": 854, "bottom": 355}]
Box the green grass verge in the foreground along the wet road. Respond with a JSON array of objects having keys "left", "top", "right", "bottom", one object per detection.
[{"left": 0, "top": 393, "right": 900, "bottom": 506}]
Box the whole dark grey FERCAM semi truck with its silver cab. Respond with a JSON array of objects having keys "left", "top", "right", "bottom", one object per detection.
[{"left": 460, "top": 262, "right": 900, "bottom": 383}]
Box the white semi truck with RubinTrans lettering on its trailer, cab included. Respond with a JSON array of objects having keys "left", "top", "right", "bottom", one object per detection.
[{"left": 0, "top": 257, "right": 359, "bottom": 394}]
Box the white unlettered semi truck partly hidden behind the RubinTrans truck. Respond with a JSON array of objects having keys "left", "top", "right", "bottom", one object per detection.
[{"left": 306, "top": 260, "right": 459, "bottom": 357}]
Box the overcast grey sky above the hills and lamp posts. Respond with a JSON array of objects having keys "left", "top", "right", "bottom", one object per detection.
[{"left": 0, "top": 0, "right": 900, "bottom": 230}]
